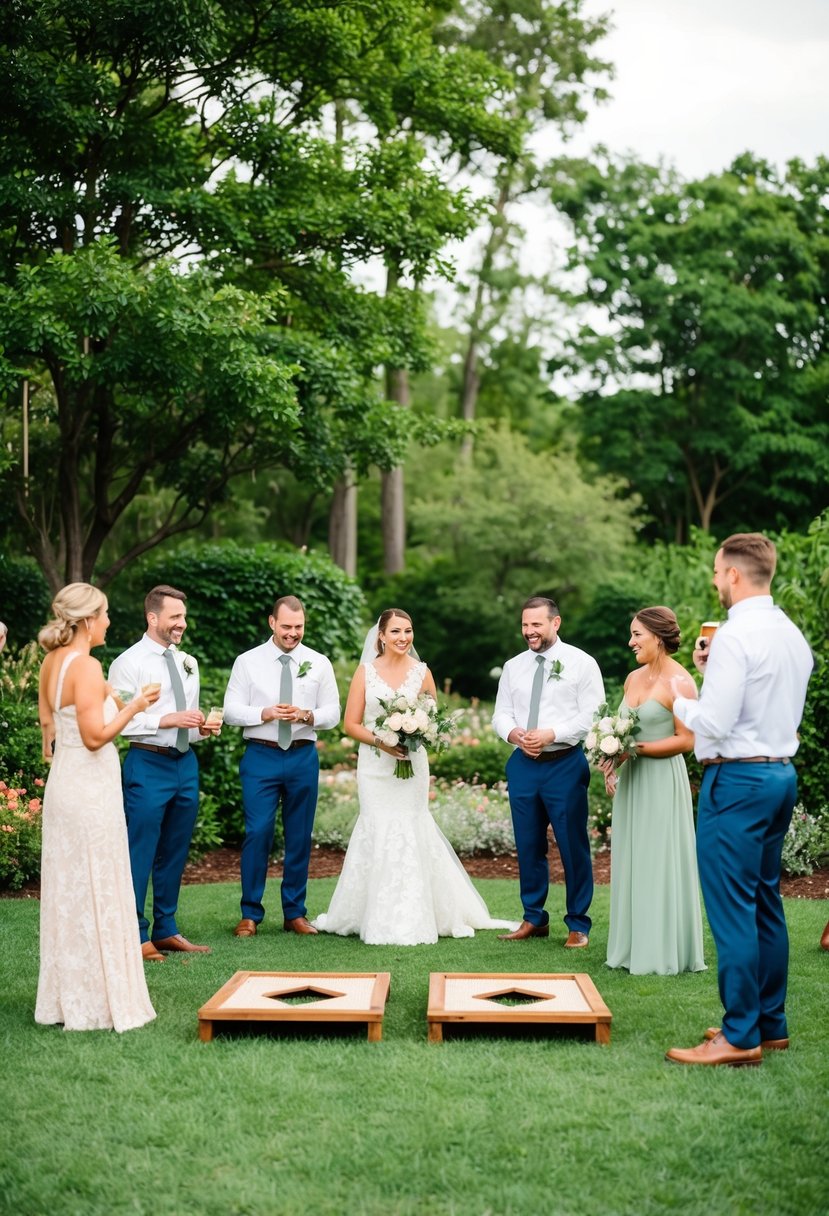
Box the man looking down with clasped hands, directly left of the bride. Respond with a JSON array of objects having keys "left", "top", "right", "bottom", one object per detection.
[{"left": 225, "top": 596, "right": 339, "bottom": 938}]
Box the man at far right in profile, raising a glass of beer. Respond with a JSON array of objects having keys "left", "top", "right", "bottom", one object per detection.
[{"left": 667, "top": 533, "right": 813, "bottom": 1065}]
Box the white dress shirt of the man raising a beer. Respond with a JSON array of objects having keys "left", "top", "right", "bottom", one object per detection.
[{"left": 673, "top": 596, "right": 814, "bottom": 760}]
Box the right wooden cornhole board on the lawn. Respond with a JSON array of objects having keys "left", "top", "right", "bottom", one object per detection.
[{"left": 427, "top": 972, "right": 613, "bottom": 1043}]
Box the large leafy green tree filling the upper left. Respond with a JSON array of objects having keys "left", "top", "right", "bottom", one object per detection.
[{"left": 0, "top": 0, "right": 509, "bottom": 586}]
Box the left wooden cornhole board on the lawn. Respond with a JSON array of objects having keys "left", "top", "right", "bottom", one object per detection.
[{"left": 198, "top": 972, "right": 391, "bottom": 1043}]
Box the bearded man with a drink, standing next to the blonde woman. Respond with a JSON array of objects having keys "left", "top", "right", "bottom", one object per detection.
[{"left": 109, "top": 586, "right": 221, "bottom": 962}]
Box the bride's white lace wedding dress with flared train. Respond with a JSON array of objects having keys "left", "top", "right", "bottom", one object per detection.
[{"left": 314, "top": 663, "right": 515, "bottom": 946}]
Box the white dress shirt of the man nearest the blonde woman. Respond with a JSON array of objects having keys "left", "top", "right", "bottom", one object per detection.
[{"left": 109, "top": 634, "right": 203, "bottom": 748}]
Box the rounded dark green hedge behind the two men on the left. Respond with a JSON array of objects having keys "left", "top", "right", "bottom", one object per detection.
[{"left": 108, "top": 544, "right": 365, "bottom": 671}]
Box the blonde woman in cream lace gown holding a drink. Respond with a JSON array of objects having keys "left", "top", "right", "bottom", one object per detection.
[{"left": 34, "top": 582, "right": 158, "bottom": 1031}]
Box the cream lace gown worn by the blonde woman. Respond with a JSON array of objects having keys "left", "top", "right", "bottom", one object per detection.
[{"left": 34, "top": 654, "right": 156, "bottom": 1031}]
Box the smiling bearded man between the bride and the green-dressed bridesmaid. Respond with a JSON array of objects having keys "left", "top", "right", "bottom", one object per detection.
[{"left": 492, "top": 596, "right": 604, "bottom": 950}]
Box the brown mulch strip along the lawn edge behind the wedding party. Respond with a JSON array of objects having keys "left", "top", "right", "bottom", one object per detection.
[{"left": 6, "top": 840, "right": 829, "bottom": 900}]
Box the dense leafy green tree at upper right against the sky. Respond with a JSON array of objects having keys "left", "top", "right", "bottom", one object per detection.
[{"left": 551, "top": 154, "right": 829, "bottom": 540}]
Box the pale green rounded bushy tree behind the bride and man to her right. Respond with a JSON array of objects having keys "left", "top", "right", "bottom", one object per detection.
[{"left": 371, "top": 427, "right": 633, "bottom": 697}]
